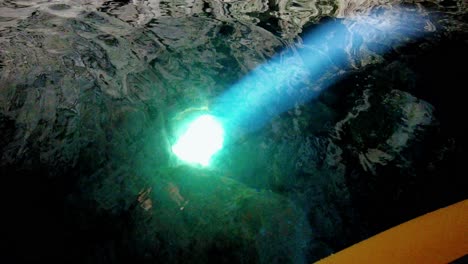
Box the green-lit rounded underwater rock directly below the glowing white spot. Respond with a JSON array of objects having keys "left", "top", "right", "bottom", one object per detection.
[{"left": 82, "top": 166, "right": 310, "bottom": 263}]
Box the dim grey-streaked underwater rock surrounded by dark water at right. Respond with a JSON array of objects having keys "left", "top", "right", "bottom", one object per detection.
[{"left": 335, "top": 89, "right": 436, "bottom": 174}]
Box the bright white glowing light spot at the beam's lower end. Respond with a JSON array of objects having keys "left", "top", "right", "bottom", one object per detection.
[{"left": 172, "top": 115, "right": 224, "bottom": 166}]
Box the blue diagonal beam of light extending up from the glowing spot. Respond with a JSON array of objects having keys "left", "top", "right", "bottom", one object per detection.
[{"left": 212, "top": 9, "right": 427, "bottom": 136}]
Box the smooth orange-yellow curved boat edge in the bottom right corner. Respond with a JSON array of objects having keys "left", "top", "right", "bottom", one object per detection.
[{"left": 317, "top": 200, "right": 468, "bottom": 264}]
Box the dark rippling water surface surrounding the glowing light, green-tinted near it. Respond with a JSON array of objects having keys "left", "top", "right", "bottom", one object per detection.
[{"left": 0, "top": 0, "right": 468, "bottom": 263}]
